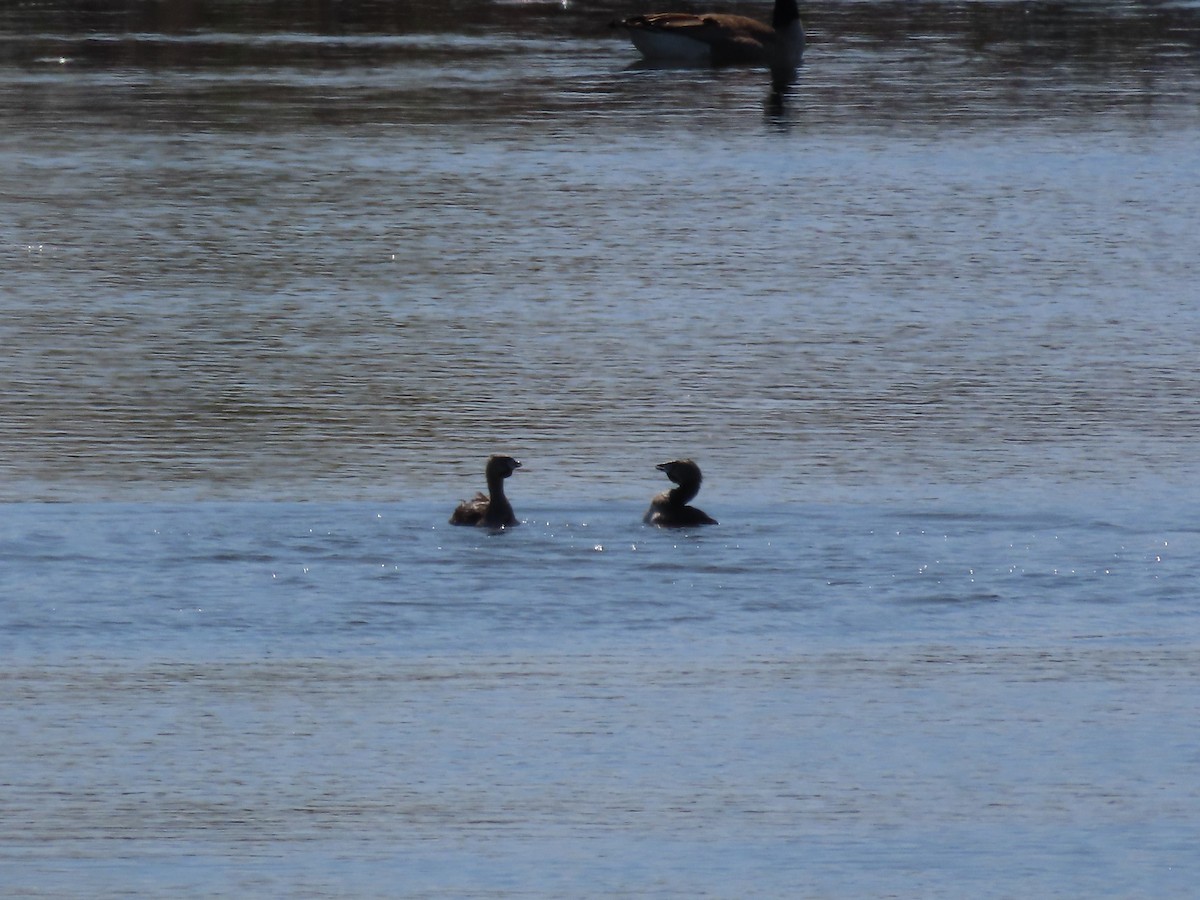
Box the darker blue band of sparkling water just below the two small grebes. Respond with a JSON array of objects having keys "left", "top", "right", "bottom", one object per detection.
[{"left": 0, "top": 492, "right": 1196, "bottom": 662}]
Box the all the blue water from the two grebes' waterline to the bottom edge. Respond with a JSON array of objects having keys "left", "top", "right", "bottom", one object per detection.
[{"left": 0, "top": 497, "right": 1200, "bottom": 896}]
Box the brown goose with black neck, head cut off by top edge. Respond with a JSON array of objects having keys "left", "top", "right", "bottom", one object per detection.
[{"left": 613, "top": 0, "right": 804, "bottom": 82}]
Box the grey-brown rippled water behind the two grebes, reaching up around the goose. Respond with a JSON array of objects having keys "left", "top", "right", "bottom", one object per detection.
[{"left": 7, "top": 5, "right": 1200, "bottom": 499}]
